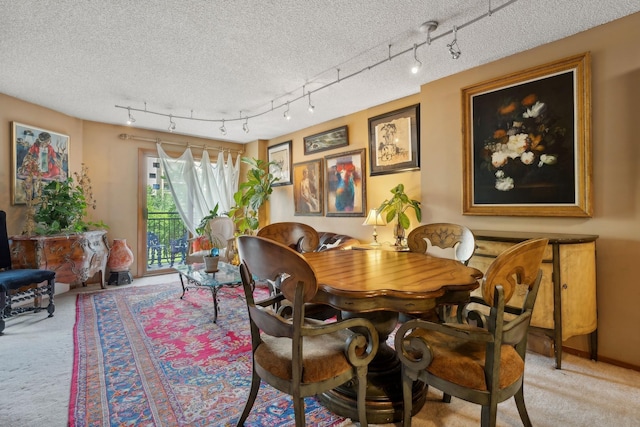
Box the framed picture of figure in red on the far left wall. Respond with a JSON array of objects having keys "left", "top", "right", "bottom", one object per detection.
[{"left": 11, "top": 122, "right": 69, "bottom": 205}]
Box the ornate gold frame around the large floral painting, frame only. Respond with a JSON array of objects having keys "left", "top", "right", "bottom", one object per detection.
[{"left": 461, "top": 52, "right": 593, "bottom": 217}]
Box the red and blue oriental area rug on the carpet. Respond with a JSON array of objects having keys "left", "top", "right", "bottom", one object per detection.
[{"left": 69, "top": 283, "right": 351, "bottom": 427}]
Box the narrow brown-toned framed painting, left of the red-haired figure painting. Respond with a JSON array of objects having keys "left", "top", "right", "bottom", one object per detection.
[{"left": 293, "top": 159, "right": 324, "bottom": 216}]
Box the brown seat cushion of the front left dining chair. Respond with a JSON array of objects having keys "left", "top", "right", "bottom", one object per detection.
[{"left": 254, "top": 333, "right": 352, "bottom": 383}]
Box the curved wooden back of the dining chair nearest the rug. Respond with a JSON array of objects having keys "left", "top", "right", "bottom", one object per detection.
[{"left": 238, "top": 236, "right": 318, "bottom": 303}]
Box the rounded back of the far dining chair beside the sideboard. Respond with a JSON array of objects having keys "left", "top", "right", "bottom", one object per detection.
[{"left": 407, "top": 222, "right": 476, "bottom": 265}]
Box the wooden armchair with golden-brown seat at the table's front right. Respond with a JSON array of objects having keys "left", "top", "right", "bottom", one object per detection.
[{"left": 395, "top": 239, "right": 548, "bottom": 427}]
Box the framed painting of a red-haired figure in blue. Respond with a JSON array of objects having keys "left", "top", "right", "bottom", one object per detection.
[{"left": 324, "top": 149, "right": 367, "bottom": 216}]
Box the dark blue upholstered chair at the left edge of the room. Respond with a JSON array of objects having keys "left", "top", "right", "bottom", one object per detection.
[{"left": 0, "top": 211, "right": 56, "bottom": 335}]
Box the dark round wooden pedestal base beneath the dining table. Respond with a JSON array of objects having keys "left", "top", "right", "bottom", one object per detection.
[{"left": 318, "top": 311, "right": 426, "bottom": 424}]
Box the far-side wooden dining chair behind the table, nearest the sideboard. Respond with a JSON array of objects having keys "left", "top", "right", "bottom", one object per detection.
[{"left": 401, "top": 222, "right": 476, "bottom": 322}]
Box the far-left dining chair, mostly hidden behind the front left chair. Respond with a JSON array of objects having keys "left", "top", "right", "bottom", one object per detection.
[{"left": 257, "top": 222, "right": 340, "bottom": 320}]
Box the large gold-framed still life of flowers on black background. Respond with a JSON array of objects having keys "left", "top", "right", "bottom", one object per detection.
[{"left": 462, "top": 53, "right": 592, "bottom": 217}]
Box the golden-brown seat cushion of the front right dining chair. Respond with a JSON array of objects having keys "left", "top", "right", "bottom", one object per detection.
[{"left": 411, "top": 325, "right": 524, "bottom": 391}]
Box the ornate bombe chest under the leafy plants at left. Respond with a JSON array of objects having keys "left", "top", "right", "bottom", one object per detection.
[{"left": 10, "top": 230, "right": 109, "bottom": 289}]
